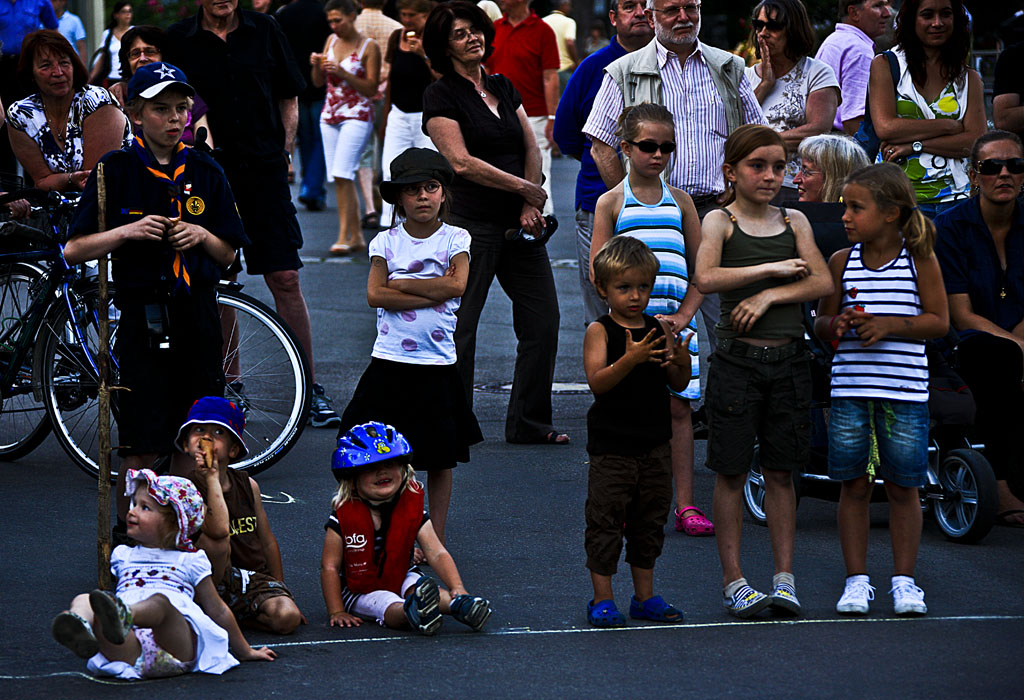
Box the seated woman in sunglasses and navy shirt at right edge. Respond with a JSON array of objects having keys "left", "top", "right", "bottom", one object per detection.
[{"left": 935, "top": 131, "right": 1024, "bottom": 527}]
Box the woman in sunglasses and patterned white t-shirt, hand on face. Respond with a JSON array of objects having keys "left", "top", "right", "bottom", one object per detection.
[{"left": 746, "top": 0, "right": 842, "bottom": 204}]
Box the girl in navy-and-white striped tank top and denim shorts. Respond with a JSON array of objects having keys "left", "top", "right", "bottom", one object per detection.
[{"left": 814, "top": 164, "right": 949, "bottom": 615}]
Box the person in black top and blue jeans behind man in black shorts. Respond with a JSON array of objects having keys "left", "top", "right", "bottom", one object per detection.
[{"left": 274, "top": 0, "right": 331, "bottom": 212}]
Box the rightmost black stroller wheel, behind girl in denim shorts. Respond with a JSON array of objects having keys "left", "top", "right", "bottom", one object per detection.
[{"left": 933, "top": 449, "right": 998, "bottom": 542}]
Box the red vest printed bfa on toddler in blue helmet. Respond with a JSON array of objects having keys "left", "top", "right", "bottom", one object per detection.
[{"left": 336, "top": 488, "right": 423, "bottom": 594}]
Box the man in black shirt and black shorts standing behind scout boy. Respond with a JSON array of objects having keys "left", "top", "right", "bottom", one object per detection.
[{"left": 167, "top": 0, "right": 341, "bottom": 428}]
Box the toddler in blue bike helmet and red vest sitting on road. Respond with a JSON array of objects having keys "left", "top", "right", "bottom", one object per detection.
[{"left": 321, "top": 422, "right": 490, "bottom": 635}]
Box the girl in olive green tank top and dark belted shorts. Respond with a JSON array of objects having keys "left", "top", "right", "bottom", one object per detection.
[{"left": 695, "top": 125, "right": 833, "bottom": 618}]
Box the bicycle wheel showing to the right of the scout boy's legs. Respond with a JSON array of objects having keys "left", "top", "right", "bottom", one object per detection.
[{"left": 217, "top": 289, "right": 312, "bottom": 474}]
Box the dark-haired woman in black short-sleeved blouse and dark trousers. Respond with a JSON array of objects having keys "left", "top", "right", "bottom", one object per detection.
[{"left": 423, "top": 0, "right": 569, "bottom": 444}]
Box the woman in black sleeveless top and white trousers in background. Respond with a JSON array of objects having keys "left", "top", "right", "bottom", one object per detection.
[{"left": 381, "top": 0, "right": 438, "bottom": 226}]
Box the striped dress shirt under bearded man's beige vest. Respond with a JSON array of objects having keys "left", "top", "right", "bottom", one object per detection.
[{"left": 583, "top": 40, "right": 767, "bottom": 196}]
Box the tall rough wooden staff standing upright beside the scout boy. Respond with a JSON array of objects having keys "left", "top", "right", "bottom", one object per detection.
[{"left": 96, "top": 163, "right": 114, "bottom": 590}]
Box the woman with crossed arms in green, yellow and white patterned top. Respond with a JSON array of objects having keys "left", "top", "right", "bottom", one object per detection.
[{"left": 868, "top": 0, "right": 986, "bottom": 218}]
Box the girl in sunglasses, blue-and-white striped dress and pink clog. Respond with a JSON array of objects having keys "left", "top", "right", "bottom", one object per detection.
[{"left": 590, "top": 102, "right": 715, "bottom": 536}]
